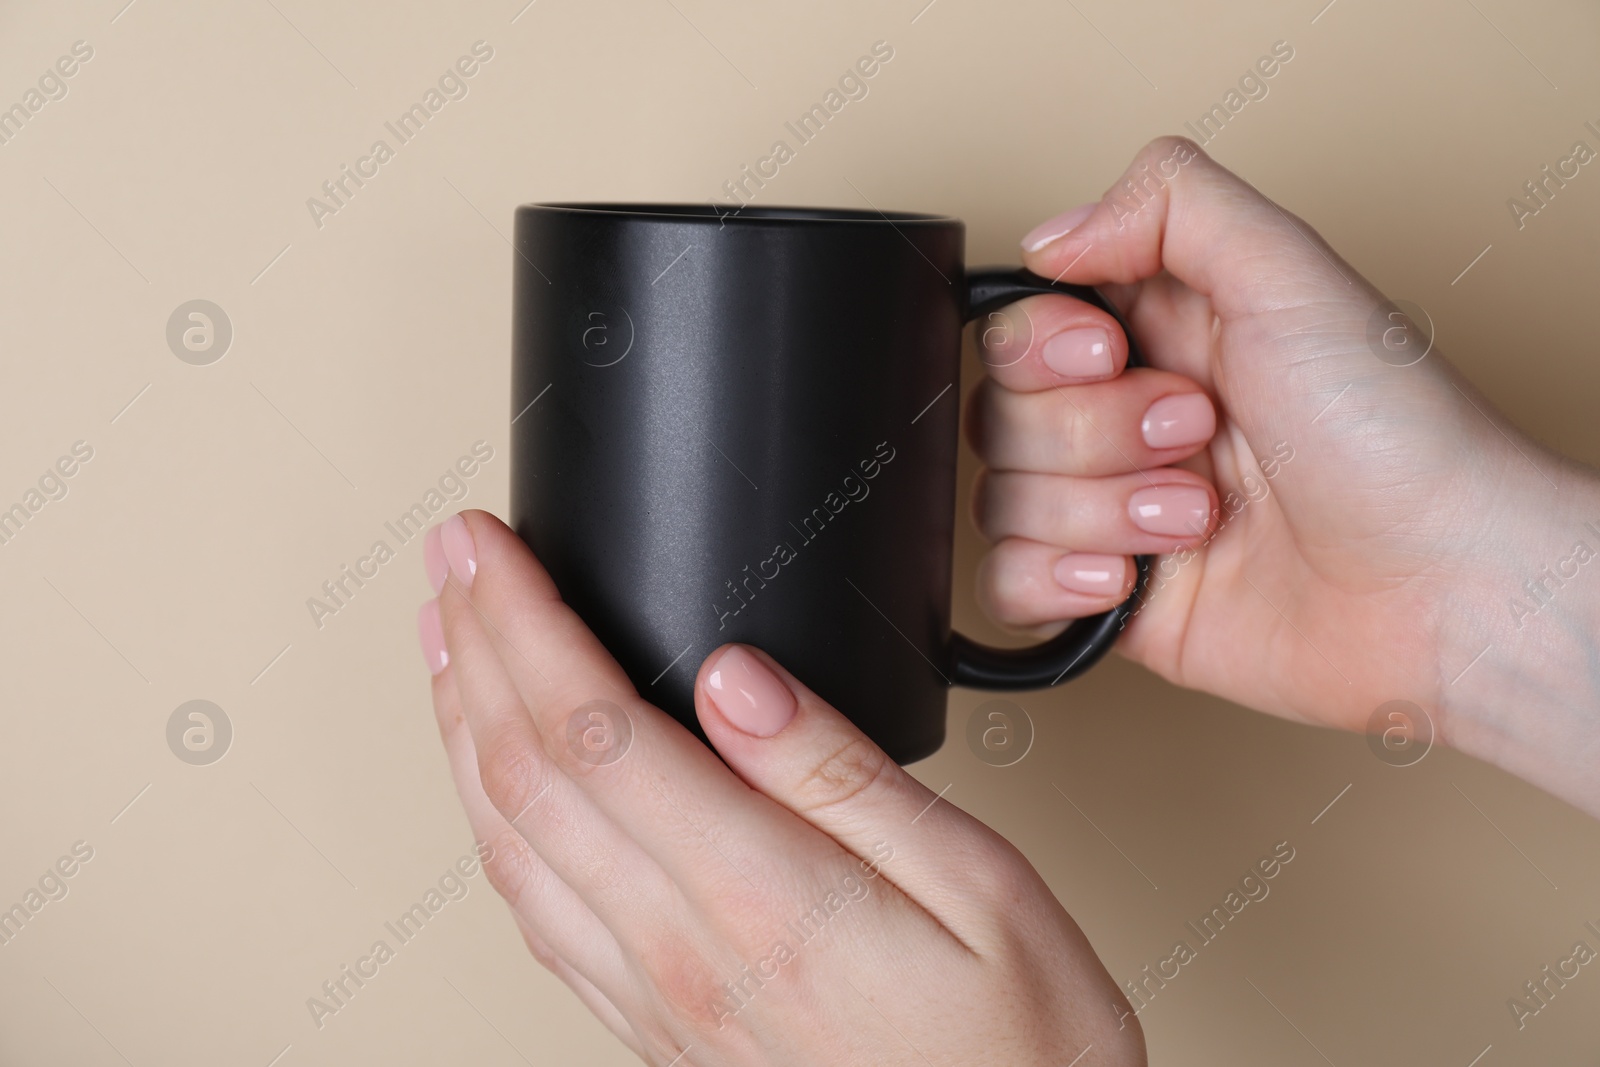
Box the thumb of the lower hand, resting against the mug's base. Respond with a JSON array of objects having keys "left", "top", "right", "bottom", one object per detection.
[{"left": 694, "top": 645, "right": 1027, "bottom": 936}]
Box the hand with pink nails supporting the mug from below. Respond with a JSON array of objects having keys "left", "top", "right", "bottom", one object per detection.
[{"left": 419, "top": 512, "right": 1144, "bottom": 1067}]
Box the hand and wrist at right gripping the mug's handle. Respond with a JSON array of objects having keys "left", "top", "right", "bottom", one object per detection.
[{"left": 970, "top": 138, "right": 1600, "bottom": 814}]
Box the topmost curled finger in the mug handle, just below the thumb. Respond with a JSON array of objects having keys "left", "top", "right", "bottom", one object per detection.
[{"left": 976, "top": 294, "right": 1128, "bottom": 392}]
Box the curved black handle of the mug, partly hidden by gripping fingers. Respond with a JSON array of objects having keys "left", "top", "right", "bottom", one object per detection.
[{"left": 946, "top": 267, "right": 1150, "bottom": 689}]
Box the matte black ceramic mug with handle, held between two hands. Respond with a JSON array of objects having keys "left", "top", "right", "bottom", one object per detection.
[{"left": 510, "top": 203, "right": 1149, "bottom": 763}]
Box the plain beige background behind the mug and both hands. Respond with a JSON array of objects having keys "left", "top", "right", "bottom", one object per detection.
[{"left": 0, "top": 0, "right": 1600, "bottom": 1067}]
